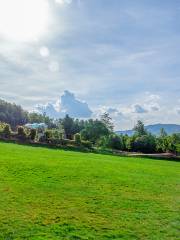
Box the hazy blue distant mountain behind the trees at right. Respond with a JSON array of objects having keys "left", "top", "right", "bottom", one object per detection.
[{"left": 116, "top": 123, "right": 180, "bottom": 136}]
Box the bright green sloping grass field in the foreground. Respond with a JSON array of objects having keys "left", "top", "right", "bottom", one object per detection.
[{"left": 0, "top": 143, "right": 180, "bottom": 240}]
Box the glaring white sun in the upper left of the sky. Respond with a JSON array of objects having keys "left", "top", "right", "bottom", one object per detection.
[{"left": 0, "top": 0, "right": 49, "bottom": 41}]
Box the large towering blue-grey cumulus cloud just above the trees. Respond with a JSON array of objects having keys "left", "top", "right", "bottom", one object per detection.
[{"left": 35, "top": 90, "right": 92, "bottom": 118}]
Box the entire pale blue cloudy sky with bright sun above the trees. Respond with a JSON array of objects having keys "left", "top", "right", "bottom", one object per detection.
[{"left": 0, "top": 0, "right": 180, "bottom": 130}]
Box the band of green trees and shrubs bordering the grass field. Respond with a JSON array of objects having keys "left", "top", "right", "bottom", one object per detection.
[{"left": 0, "top": 101, "right": 180, "bottom": 153}]
